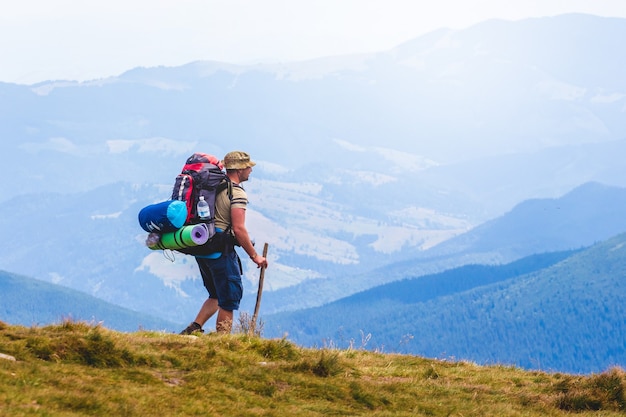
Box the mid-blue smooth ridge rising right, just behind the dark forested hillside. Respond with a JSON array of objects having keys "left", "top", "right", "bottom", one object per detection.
[{"left": 251, "top": 183, "right": 626, "bottom": 313}]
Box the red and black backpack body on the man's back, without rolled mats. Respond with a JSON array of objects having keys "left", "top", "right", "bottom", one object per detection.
[{"left": 171, "top": 153, "right": 232, "bottom": 225}]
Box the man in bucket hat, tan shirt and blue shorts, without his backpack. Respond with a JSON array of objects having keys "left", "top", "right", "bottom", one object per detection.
[{"left": 180, "top": 151, "right": 267, "bottom": 334}]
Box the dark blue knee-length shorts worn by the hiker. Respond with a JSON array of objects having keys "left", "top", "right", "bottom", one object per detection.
[{"left": 196, "top": 250, "right": 243, "bottom": 311}]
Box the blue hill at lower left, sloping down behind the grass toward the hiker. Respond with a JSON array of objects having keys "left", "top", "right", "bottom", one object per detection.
[{"left": 0, "top": 271, "right": 181, "bottom": 331}]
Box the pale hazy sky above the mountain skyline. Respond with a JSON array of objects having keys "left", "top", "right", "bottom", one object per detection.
[{"left": 0, "top": 0, "right": 626, "bottom": 84}]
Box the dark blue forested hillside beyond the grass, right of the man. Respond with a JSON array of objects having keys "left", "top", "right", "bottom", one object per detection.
[{"left": 265, "top": 234, "right": 626, "bottom": 373}]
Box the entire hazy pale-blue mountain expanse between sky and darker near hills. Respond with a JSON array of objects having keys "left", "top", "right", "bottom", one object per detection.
[{"left": 0, "top": 14, "right": 626, "bottom": 370}]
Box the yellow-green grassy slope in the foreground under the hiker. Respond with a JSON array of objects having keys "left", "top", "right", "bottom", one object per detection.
[{"left": 0, "top": 322, "right": 626, "bottom": 417}]
